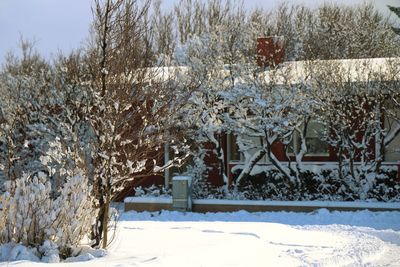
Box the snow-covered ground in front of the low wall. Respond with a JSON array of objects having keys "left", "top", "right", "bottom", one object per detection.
[{"left": 1, "top": 209, "right": 400, "bottom": 267}]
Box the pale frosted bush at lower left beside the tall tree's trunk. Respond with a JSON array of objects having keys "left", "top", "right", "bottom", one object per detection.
[{"left": 0, "top": 172, "right": 95, "bottom": 260}]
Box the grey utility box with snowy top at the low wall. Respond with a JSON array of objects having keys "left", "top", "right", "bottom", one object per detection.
[{"left": 172, "top": 176, "right": 192, "bottom": 211}]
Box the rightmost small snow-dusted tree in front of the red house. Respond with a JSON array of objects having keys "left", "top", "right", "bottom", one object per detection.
[{"left": 313, "top": 59, "right": 394, "bottom": 197}]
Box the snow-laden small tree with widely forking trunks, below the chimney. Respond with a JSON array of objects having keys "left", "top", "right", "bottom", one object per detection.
[{"left": 226, "top": 62, "right": 312, "bottom": 189}]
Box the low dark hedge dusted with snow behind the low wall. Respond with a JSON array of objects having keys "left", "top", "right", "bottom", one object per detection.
[{"left": 192, "top": 167, "right": 400, "bottom": 202}]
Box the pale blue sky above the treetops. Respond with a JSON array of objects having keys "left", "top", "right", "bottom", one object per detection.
[{"left": 0, "top": 0, "right": 400, "bottom": 64}]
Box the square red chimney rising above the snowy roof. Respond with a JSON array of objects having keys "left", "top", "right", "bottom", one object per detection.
[{"left": 257, "top": 36, "right": 285, "bottom": 67}]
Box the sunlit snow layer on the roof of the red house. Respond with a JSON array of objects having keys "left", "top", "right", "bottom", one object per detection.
[{"left": 127, "top": 57, "right": 400, "bottom": 84}]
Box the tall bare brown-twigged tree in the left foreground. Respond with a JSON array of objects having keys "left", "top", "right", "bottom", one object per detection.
[{"left": 85, "top": 0, "right": 189, "bottom": 248}]
